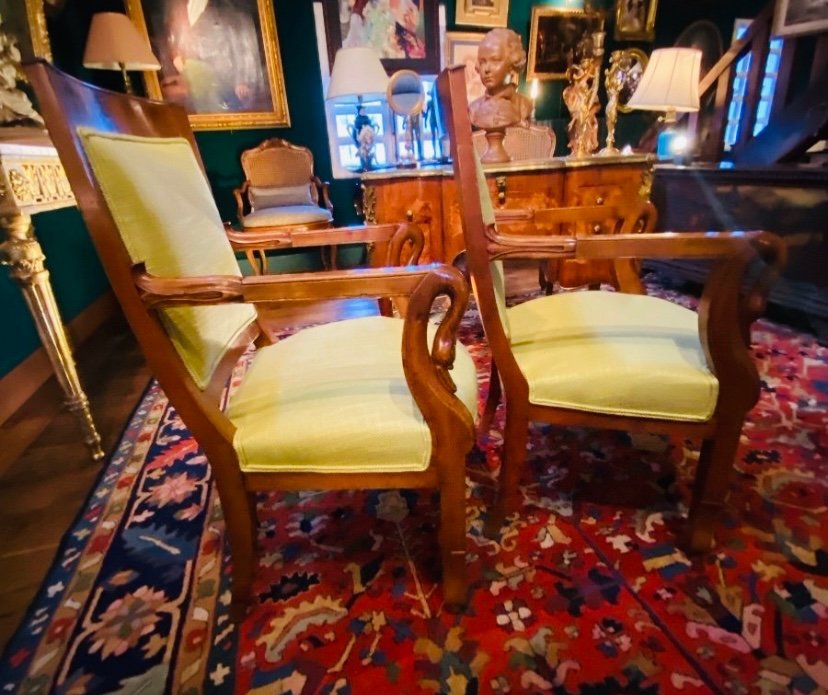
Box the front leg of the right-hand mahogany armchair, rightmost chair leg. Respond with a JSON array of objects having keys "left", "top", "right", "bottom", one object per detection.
[{"left": 682, "top": 417, "right": 744, "bottom": 553}]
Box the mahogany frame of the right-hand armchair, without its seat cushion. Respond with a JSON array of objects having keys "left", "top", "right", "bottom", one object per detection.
[{"left": 438, "top": 67, "right": 785, "bottom": 551}]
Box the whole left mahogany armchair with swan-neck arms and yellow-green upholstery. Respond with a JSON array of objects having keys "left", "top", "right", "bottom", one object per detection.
[{"left": 26, "top": 61, "right": 477, "bottom": 617}]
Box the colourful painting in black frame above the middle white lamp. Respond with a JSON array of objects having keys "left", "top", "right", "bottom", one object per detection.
[{"left": 322, "top": 0, "right": 440, "bottom": 75}]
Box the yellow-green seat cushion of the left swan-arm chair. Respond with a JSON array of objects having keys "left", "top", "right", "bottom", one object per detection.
[{"left": 227, "top": 316, "right": 477, "bottom": 473}]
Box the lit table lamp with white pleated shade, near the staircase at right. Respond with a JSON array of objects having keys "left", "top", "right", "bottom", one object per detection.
[{"left": 627, "top": 48, "right": 702, "bottom": 159}]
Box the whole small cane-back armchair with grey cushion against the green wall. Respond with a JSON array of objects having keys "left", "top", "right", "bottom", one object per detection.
[{"left": 233, "top": 138, "right": 336, "bottom": 275}]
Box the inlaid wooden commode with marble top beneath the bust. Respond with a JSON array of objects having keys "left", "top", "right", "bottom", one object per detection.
[{"left": 361, "top": 154, "right": 653, "bottom": 272}]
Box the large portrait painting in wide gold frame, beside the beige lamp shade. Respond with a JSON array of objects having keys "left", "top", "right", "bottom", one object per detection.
[{"left": 127, "top": 0, "right": 290, "bottom": 130}]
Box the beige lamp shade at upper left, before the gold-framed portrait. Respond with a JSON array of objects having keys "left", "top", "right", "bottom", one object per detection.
[{"left": 83, "top": 12, "right": 161, "bottom": 70}]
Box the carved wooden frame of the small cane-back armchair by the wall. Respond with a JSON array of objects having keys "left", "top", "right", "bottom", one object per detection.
[{"left": 233, "top": 138, "right": 336, "bottom": 275}]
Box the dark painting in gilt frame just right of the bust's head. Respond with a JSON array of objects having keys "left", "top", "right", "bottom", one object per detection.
[{"left": 526, "top": 6, "right": 604, "bottom": 80}]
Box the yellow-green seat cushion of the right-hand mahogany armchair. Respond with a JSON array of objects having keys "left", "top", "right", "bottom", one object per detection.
[{"left": 508, "top": 292, "right": 719, "bottom": 421}]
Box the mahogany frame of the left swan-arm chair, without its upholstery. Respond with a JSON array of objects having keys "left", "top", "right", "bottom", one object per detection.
[{"left": 25, "top": 61, "right": 474, "bottom": 617}]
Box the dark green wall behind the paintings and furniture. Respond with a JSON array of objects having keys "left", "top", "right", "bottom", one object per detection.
[{"left": 0, "top": 0, "right": 765, "bottom": 375}]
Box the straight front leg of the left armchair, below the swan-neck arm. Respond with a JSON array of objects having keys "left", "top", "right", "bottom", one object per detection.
[{"left": 440, "top": 456, "right": 468, "bottom": 612}]
